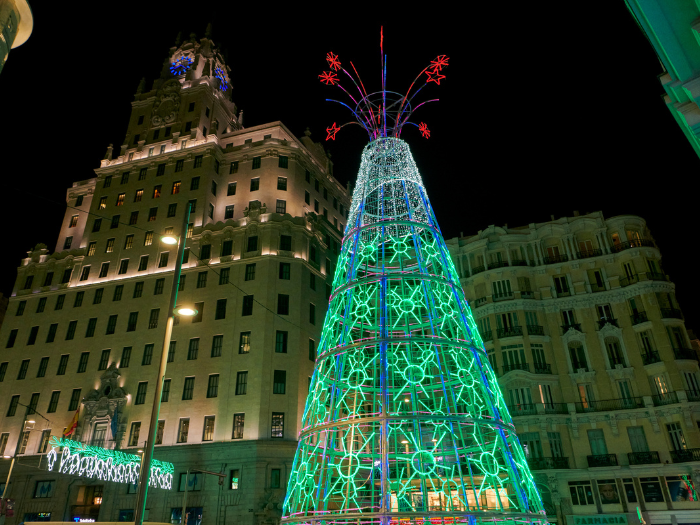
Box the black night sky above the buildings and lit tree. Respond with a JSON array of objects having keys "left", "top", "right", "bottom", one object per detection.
[{"left": 0, "top": 0, "right": 700, "bottom": 329}]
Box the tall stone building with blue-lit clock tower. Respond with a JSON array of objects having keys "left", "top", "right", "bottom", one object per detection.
[{"left": 0, "top": 38, "right": 349, "bottom": 525}]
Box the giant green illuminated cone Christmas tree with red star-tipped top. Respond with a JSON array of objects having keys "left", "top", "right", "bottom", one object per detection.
[{"left": 282, "top": 35, "right": 546, "bottom": 525}]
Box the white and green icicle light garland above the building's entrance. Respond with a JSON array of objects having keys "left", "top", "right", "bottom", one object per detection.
[{"left": 46, "top": 436, "right": 175, "bottom": 489}]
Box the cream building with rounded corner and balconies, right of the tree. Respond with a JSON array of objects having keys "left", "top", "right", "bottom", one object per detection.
[{"left": 447, "top": 212, "right": 700, "bottom": 525}]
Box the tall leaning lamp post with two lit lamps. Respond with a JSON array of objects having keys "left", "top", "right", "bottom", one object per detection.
[{"left": 134, "top": 203, "right": 196, "bottom": 525}]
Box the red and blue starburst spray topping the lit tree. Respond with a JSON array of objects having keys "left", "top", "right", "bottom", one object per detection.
[{"left": 319, "top": 27, "right": 449, "bottom": 140}]
